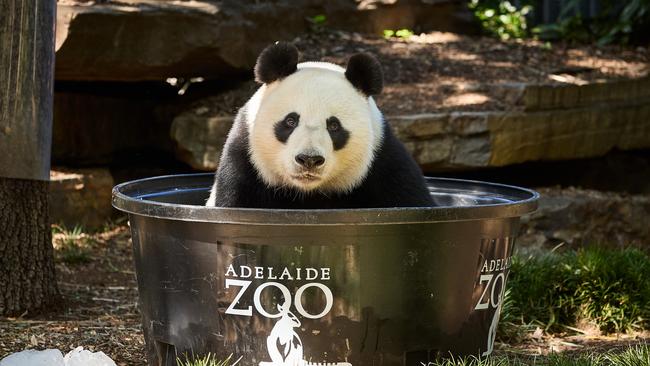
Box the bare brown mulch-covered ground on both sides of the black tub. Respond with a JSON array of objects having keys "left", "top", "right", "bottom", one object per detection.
[{"left": 0, "top": 221, "right": 650, "bottom": 366}]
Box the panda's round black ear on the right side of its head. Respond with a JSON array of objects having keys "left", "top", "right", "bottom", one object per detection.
[{"left": 345, "top": 53, "right": 384, "bottom": 96}]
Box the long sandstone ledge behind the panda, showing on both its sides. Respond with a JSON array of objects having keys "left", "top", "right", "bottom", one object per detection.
[{"left": 172, "top": 92, "right": 650, "bottom": 172}]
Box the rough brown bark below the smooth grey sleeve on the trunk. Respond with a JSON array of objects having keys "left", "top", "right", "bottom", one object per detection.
[{"left": 0, "top": 178, "right": 59, "bottom": 315}]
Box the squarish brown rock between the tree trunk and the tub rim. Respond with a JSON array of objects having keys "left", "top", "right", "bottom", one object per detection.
[{"left": 50, "top": 168, "right": 114, "bottom": 229}]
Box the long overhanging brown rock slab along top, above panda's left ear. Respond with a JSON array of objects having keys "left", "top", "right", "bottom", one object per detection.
[{"left": 55, "top": 0, "right": 472, "bottom": 81}]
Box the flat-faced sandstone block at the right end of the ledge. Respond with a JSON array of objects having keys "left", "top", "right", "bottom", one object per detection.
[{"left": 487, "top": 104, "right": 650, "bottom": 166}]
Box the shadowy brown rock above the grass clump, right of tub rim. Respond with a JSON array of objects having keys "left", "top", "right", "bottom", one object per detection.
[{"left": 518, "top": 188, "right": 650, "bottom": 247}]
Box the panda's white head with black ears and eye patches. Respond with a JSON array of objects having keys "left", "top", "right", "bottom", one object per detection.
[{"left": 246, "top": 43, "right": 383, "bottom": 193}]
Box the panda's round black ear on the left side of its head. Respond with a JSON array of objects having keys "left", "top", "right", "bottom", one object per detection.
[{"left": 255, "top": 42, "right": 298, "bottom": 84}]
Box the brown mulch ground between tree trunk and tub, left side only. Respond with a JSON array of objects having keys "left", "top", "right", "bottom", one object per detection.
[{"left": 0, "top": 224, "right": 146, "bottom": 365}]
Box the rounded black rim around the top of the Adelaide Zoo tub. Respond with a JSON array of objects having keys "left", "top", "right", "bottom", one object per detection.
[{"left": 112, "top": 173, "right": 539, "bottom": 226}]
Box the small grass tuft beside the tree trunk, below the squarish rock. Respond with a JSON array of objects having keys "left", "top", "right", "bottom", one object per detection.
[{"left": 52, "top": 225, "right": 93, "bottom": 264}]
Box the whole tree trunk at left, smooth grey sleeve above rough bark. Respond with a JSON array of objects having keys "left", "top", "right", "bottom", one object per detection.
[{"left": 0, "top": 0, "right": 58, "bottom": 315}]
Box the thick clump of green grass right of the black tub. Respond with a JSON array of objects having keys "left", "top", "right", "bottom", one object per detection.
[{"left": 503, "top": 248, "right": 650, "bottom": 333}]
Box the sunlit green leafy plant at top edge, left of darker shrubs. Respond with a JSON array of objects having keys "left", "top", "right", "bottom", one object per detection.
[{"left": 469, "top": 0, "right": 533, "bottom": 40}]
